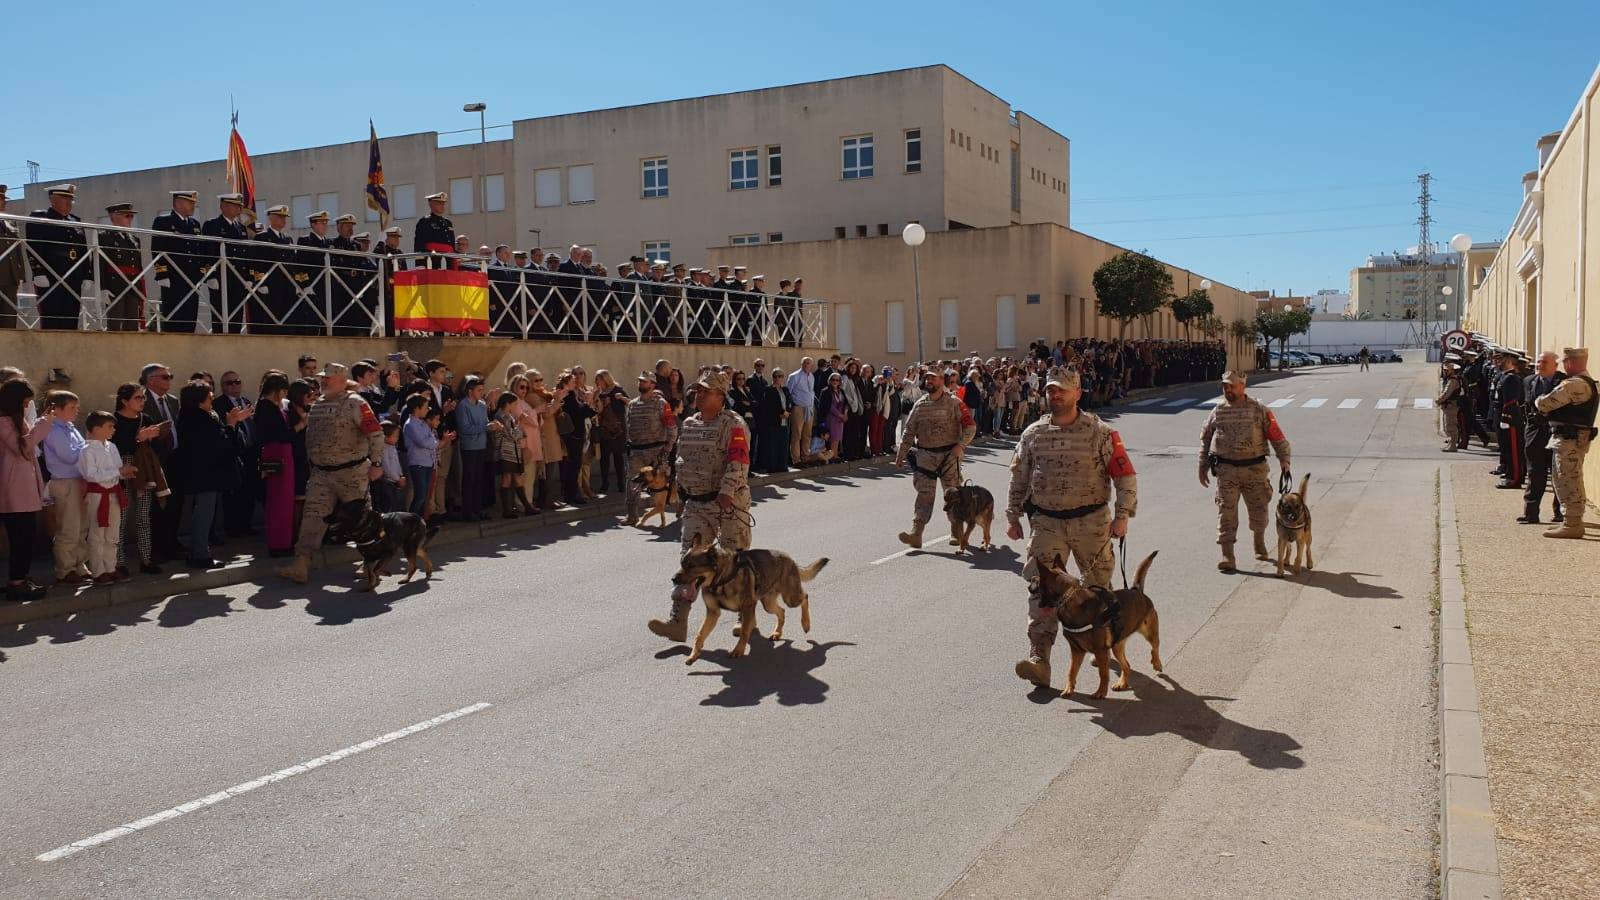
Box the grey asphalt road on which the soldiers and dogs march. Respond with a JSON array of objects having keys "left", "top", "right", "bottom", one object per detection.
[{"left": 0, "top": 365, "right": 1440, "bottom": 898}]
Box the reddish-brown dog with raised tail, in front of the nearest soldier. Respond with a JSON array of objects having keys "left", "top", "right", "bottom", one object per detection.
[{"left": 1037, "top": 552, "right": 1162, "bottom": 700}]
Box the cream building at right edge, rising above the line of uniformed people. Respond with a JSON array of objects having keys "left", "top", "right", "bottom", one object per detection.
[{"left": 1466, "top": 60, "right": 1600, "bottom": 498}]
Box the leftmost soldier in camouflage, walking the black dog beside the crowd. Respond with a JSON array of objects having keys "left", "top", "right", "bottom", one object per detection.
[{"left": 278, "top": 362, "right": 384, "bottom": 585}]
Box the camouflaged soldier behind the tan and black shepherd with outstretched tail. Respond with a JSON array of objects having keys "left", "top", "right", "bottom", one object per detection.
[{"left": 646, "top": 372, "right": 752, "bottom": 641}]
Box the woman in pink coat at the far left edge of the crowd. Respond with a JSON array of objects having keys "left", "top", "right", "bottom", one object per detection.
[{"left": 0, "top": 378, "right": 54, "bottom": 602}]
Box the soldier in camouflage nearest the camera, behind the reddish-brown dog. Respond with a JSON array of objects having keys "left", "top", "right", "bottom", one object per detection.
[{"left": 1005, "top": 368, "right": 1139, "bottom": 687}]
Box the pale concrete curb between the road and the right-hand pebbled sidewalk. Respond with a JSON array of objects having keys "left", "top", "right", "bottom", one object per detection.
[{"left": 1438, "top": 466, "right": 1501, "bottom": 900}]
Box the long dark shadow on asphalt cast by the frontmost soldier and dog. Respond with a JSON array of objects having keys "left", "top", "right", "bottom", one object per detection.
[{"left": 1072, "top": 660, "right": 1306, "bottom": 769}]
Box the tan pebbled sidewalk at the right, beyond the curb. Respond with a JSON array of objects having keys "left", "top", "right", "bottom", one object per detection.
[{"left": 1445, "top": 463, "right": 1600, "bottom": 897}]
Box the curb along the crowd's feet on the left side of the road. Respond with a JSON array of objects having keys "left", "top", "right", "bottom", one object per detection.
[{"left": 0, "top": 456, "right": 893, "bottom": 628}]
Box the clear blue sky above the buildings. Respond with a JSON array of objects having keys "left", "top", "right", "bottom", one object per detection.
[{"left": 0, "top": 0, "right": 1600, "bottom": 293}]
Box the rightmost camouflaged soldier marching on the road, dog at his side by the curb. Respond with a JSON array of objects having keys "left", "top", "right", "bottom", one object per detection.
[{"left": 1200, "top": 372, "right": 1290, "bottom": 572}]
